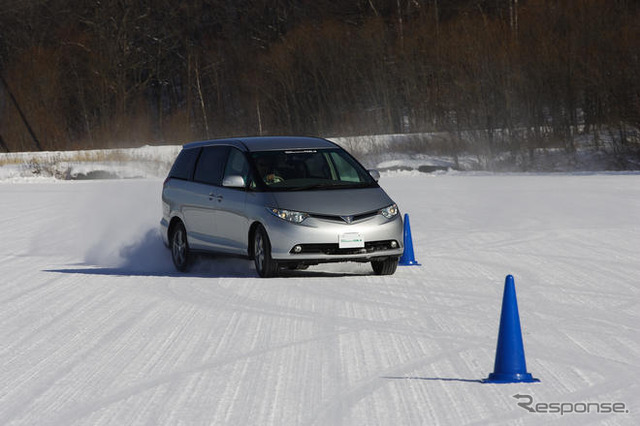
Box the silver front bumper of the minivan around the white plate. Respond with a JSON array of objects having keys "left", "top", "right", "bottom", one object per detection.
[{"left": 264, "top": 214, "right": 404, "bottom": 263}]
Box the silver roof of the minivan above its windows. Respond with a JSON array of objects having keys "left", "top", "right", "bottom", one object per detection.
[{"left": 183, "top": 136, "right": 338, "bottom": 151}]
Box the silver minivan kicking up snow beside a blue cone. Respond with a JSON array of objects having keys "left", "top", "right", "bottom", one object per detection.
[{"left": 161, "top": 136, "right": 403, "bottom": 277}]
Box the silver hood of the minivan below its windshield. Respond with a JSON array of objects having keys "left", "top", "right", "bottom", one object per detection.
[{"left": 272, "top": 188, "right": 393, "bottom": 216}]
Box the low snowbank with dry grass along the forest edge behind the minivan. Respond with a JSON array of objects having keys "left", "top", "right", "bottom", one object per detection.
[{"left": 0, "top": 135, "right": 640, "bottom": 182}]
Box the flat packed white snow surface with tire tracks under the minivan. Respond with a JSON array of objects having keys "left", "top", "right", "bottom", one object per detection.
[{"left": 0, "top": 172, "right": 640, "bottom": 425}]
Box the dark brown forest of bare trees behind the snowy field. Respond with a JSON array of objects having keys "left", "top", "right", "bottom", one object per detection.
[{"left": 0, "top": 0, "right": 640, "bottom": 161}]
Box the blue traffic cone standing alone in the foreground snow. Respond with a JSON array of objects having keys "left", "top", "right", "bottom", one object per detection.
[{"left": 483, "top": 275, "right": 540, "bottom": 383}]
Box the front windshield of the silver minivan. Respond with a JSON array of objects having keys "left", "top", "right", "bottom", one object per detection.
[{"left": 251, "top": 148, "right": 377, "bottom": 191}]
